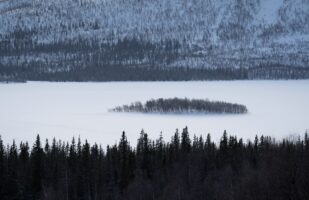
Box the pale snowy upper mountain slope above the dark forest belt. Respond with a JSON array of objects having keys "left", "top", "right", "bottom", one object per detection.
[{"left": 0, "top": 0, "right": 309, "bottom": 44}]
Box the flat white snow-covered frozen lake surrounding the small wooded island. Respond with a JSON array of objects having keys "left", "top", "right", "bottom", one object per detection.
[{"left": 0, "top": 80, "right": 309, "bottom": 146}]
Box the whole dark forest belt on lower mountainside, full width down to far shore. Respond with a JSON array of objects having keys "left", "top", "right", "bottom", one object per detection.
[{"left": 0, "top": 28, "right": 309, "bottom": 81}]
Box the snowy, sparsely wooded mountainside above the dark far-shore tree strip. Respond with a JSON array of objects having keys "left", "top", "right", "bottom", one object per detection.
[{"left": 0, "top": 0, "right": 309, "bottom": 81}]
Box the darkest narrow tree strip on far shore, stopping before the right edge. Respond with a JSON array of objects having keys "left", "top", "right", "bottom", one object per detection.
[{"left": 0, "top": 63, "right": 247, "bottom": 82}]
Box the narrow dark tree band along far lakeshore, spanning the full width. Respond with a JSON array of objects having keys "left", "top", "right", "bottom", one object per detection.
[{"left": 0, "top": 61, "right": 309, "bottom": 82}]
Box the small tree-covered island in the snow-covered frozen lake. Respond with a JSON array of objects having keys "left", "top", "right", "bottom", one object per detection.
[{"left": 110, "top": 98, "right": 248, "bottom": 114}]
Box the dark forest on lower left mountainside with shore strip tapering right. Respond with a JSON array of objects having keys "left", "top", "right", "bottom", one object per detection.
[{"left": 0, "top": 30, "right": 247, "bottom": 81}]
